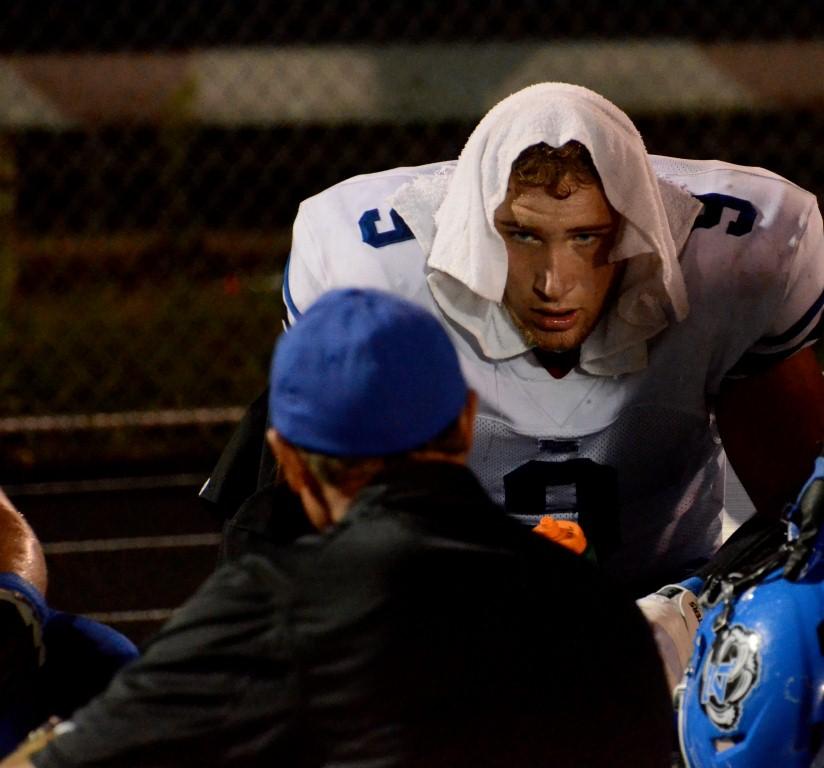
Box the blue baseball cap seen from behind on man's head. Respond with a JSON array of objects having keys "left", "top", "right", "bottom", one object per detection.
[{"left": 269, "top": 288, "right": 467, "bottom": 457}]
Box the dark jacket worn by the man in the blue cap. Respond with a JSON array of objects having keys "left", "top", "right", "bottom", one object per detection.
[{"left": 35, "top": 463, "right": 672, "bottom": 768}]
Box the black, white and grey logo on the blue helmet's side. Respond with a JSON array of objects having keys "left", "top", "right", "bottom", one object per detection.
[{"left": 701, "top": 624, "right": 761, "bottom": 730}]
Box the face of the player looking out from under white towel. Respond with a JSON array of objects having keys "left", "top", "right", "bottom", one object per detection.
[{"left": 495, "top": 177, "right": 620, "bottom": 352}]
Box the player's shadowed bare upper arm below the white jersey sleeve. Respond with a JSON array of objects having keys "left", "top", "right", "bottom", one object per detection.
[{"left": 715, "top": 347, "right": 824, "bottom": 518}]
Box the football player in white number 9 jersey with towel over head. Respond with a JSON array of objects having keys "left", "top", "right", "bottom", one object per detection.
[{"left": 202, "top": 83, "right": 824, "bottom": 596}]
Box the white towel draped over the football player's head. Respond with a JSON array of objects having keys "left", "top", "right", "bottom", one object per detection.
[{"left": 392, "top": 83, "right": 701, "bottom": 375}]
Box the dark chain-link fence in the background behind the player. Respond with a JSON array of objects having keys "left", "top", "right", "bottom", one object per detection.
[{"left": 0, "top": 0, "right": 824, "bottom": 481}]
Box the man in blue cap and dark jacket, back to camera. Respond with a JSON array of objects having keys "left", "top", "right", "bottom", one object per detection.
[{"left": 3, "top": 289, "right": 672, "bottom": 768}]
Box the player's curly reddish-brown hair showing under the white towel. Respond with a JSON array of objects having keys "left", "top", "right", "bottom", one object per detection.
[{"left": 512, "top": 140, "right": 601, "bottom": 200}]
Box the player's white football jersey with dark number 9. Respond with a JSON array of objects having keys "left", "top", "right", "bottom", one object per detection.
[{"left": 284, "top": 157, "right": 824, "bottom": 584}]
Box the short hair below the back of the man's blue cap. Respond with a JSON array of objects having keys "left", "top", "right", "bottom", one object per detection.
[{"left": 292, "top": 416, "right": 468, "bottom": 490}]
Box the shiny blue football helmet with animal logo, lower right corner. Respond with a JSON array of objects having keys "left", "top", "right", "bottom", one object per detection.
[{"left": 677, "top": 455, "right": 824, "bottom": 768}]
